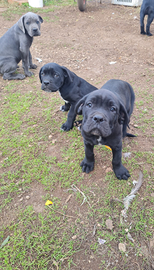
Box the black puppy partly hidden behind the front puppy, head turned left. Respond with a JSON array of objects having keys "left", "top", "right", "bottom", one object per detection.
[{"left": 39, "top": 63, "right": 97, "bottom": 131}]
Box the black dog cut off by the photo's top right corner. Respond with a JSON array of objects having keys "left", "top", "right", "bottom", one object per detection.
[{"left": 140, "top": 0, "right": 154, "bottom": 36}]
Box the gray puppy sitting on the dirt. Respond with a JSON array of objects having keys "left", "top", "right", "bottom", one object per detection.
[{"left": 0, "top": 12, "right": 43, "bottom": 80}]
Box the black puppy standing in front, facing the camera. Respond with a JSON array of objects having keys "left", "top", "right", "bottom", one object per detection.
[{"left": 76, "top": 80, "right": 135, "bottom": 180}]
